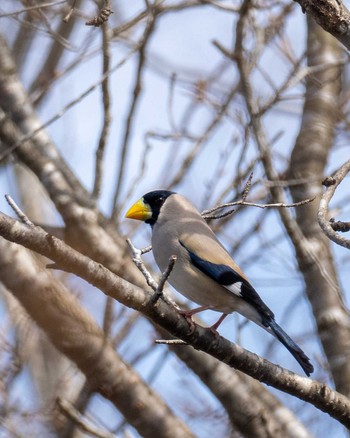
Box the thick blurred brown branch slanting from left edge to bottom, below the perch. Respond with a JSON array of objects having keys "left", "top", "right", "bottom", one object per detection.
[{"left": 0, "top": 234, "right": 192, "bottom": 438}]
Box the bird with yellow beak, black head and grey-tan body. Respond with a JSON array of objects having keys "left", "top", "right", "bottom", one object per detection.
[{"left": 125, "top": 190, "right": 314, "bottom": 376}]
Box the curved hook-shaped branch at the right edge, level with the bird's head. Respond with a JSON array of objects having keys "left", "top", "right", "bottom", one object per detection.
[{"left": 317, "top": 160, "right": 350, "bottom": 249}]
